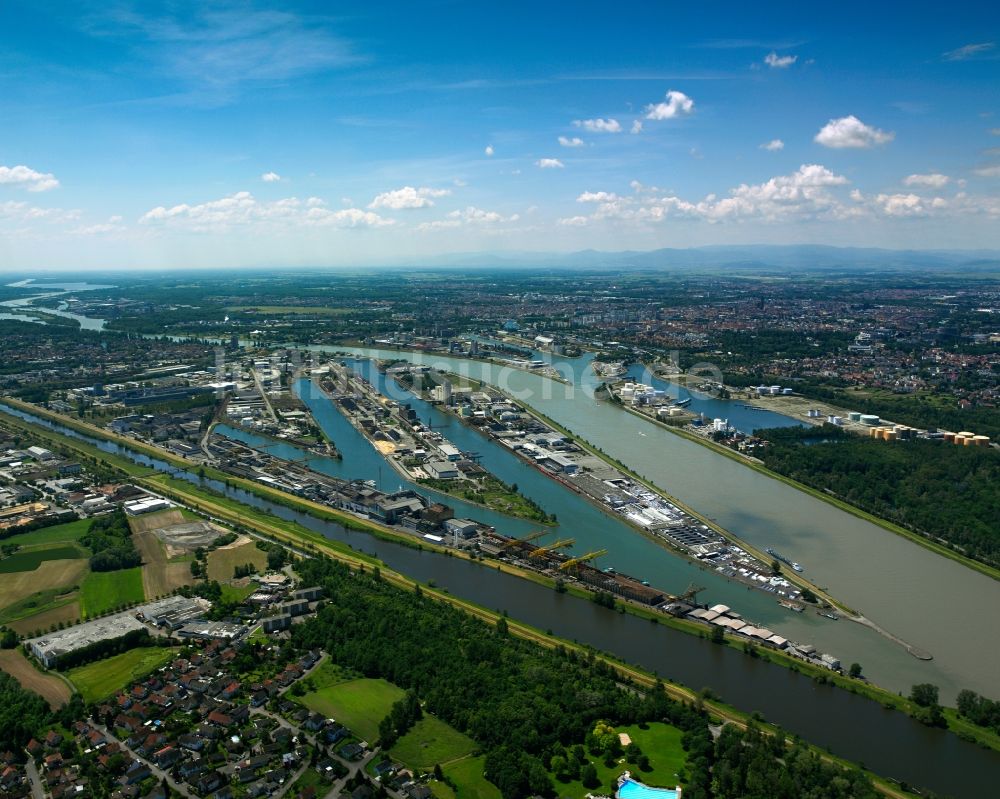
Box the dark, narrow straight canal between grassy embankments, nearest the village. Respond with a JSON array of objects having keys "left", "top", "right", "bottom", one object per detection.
[{"left": 0, "top": 407, "right": 1000, "bottom": 799}]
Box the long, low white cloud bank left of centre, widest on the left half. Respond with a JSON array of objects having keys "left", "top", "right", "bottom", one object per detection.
[{"left": 139, "top": 191, "right": 394, "bottom": 232}]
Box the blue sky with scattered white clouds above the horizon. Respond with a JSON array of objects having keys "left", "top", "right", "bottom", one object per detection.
[{"left": 0, "top": 0, "right": 1000, "bottom": 270}]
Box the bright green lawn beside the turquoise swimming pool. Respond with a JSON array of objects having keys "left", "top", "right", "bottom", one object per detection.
[{"left": 552, "top": 723, "right": 687, "bottom": 799}]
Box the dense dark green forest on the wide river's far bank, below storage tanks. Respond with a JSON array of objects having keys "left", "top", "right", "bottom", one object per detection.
[{"left": 755, "top": 425, "right": 1000, "bottom": 566}]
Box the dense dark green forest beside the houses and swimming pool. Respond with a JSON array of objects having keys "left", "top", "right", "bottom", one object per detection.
[{"left": 292, "top": 559, "right": 874, "bottom": 799}]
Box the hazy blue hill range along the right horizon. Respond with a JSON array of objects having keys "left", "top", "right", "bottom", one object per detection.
[{"left": 411, "top": 244, "right": 1000, "bottom": 272}]
